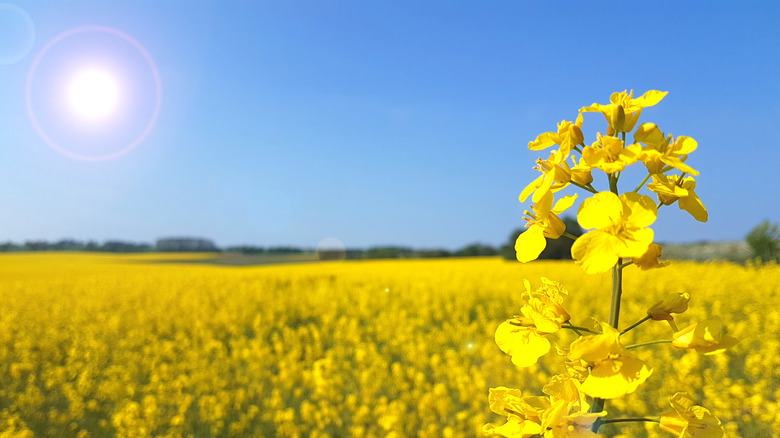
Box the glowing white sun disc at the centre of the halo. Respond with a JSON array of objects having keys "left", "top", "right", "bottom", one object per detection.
[{"left": 68, "top": 68, "right": 120, "bottom": 120}]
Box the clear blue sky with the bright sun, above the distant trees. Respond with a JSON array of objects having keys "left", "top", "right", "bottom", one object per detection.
[{"left": 0, "top": 0, "right": 780, "bottom": 249}]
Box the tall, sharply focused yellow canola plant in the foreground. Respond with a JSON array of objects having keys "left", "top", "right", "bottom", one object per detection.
[{"left": 482, "top": 90, "right": 737, "bottom": 438}]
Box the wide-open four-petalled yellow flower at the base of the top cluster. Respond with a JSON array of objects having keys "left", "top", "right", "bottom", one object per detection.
[{"left": 571, "top": 192, "right": 657, "bottom": 274}]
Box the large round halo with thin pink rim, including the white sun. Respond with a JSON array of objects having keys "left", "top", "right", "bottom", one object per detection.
[{"left": 26, "top": 26, "right": 162, "bottom": 161}]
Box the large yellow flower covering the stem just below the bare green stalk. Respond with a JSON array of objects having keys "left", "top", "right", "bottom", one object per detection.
[{"left": 568, "top": 323, "right": 653, "bottom": 399}]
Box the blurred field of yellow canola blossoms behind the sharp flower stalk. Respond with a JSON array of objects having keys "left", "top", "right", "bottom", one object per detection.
[{"left": 0, "top": 253, "right": 780, "bottom": 438}]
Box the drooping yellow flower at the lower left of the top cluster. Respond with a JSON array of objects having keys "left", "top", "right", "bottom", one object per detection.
[{"left": 515, "top": 192, "right": 577, "bottom": 263}]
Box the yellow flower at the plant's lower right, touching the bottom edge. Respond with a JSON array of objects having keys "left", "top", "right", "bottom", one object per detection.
[{"left": 660, "top": 392, "right": 723, "bottom": 438}]
